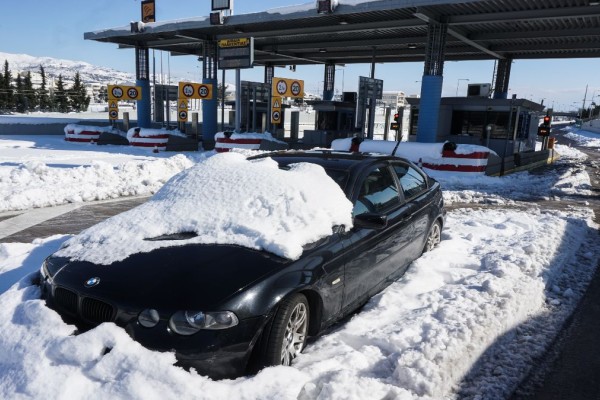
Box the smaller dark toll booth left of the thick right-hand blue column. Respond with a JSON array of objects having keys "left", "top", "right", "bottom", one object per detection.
[{"left": 303, "top": 92, "right": 358, "bottom": 147}]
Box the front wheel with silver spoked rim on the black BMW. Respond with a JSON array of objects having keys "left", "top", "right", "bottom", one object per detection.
[{"left": 261, "top": 293, "right": 310, "bottom": 367}]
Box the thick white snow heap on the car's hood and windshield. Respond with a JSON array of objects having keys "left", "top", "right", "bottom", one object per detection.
[{"left": 57, "top": 153, "right": 352, "bottom": 264}]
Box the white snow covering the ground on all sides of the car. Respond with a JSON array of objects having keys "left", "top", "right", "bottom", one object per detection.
[{"left": 0, "top": 130, "right": 600, "bottom": 400}]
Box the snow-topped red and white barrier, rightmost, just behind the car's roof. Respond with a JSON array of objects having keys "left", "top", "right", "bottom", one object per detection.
[{"left": 331, "top": 138, "right": 492, "bottom": 174}]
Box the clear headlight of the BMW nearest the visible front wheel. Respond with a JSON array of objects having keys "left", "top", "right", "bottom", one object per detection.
[{"left": 169, "top": 311, "right": 239, "bottom": 335}]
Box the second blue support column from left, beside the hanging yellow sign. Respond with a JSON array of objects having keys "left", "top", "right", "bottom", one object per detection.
[{"left": 202, "top": 41, "right": 219, "bottom": 143}]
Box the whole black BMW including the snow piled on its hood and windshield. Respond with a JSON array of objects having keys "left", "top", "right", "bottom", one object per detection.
[{"left": 36, "top": 151, "right": 444, "bottom": 378}]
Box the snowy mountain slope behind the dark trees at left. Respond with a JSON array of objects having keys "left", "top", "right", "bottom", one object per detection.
[{"left": 0, "top": 52, "right": 135, "bottom": 84}]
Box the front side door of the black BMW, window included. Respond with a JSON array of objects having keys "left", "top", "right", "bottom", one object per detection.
[{"left": 343, "top": 163, "right": 413, "bottom": 309}]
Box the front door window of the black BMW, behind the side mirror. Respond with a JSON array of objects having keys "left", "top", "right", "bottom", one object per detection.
[{"left": 353, "top": 167, "right": 400, "bottom": 216}]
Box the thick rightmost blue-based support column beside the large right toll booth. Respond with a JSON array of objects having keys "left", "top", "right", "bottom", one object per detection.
[{"left": 417, "top": 21, "right": 448, "bottom": 143}]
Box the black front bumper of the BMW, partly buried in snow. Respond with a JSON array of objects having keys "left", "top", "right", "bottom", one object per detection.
[{"left": 40, "top": 276, "right": 267, "bottom": 379}]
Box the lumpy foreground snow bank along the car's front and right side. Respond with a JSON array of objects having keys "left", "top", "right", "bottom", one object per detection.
[{"left": 0, "top": 208, "right": 600, "bottom": 400}]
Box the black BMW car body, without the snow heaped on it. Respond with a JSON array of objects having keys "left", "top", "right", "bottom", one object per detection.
[{"left": 41, "top": 151, "right": 445, "bottom": 379}]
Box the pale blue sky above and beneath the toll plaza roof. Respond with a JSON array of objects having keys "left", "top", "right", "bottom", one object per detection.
[{"left": 0, "top": 0, "right": 600, "bottom": 110}]
